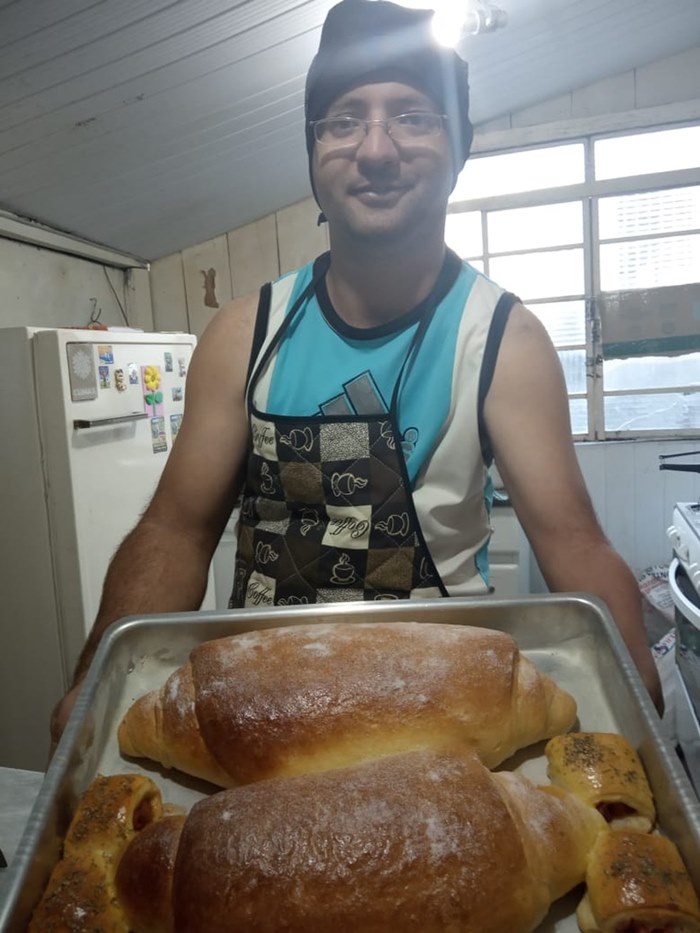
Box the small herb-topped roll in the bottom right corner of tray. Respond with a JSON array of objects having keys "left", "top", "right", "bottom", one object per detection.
[{"left": 576, "top": 831, "right": 700, "bottom": 933}]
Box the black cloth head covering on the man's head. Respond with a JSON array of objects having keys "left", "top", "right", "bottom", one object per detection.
[{"left": 304, "top": 0, "right": 474, "bottom": 205}]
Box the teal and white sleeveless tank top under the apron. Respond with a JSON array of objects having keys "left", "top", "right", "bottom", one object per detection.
[{"left": 246, "top": 251, "right": 514, "bottom": 596}]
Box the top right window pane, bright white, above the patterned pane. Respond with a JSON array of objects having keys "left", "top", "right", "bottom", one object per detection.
[{"left": 592, "top": 126, "right": 700, "bottom": 178}]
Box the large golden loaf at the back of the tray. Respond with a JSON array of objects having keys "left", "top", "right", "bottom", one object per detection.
[{"left": 119, "top": 622, "right": 576, "bottom": 787}]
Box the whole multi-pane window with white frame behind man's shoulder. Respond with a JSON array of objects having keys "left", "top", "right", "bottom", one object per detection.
[{"left": 446, "top": 126, "right": 700, "bottom": 439}]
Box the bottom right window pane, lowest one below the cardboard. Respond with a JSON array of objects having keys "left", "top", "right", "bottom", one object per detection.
[{"left": 605, "top": 392, "right": 700, "bottom": 431}]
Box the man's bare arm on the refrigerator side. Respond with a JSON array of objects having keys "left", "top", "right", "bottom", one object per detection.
[{"left": 51, "top": 295, "right": 257, "bottom": 742}]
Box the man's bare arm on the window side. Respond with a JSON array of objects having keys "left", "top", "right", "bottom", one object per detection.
[{"left": 484, "top": 305, "right": 663, "bottom": 709}]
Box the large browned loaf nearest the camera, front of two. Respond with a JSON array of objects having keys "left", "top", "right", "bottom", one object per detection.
[{"left": 117, "top": 749, "right": 607, "bottom": 933}]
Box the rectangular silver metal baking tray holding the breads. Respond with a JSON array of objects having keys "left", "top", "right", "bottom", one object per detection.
[{"left": 0, "top": 594, "right": 700, "bottom": 933}]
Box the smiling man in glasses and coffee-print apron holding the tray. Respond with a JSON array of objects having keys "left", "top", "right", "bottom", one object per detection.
[{"left": 54, "top": 0, "right": 661, "bottom": 736}]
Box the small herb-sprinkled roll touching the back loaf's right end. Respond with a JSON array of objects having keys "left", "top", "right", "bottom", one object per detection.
[{"left": 545, "top": 732, "right": 656, "bottom": 832}]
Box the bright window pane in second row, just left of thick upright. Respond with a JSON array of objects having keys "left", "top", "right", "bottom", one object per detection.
[{"left": 487, "top": 200, "right": 584, "bottom": 253}]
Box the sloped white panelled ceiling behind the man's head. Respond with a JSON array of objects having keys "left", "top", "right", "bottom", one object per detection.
[{"left": 0, "top": 0, "right": 700, "bottom": 259}]
